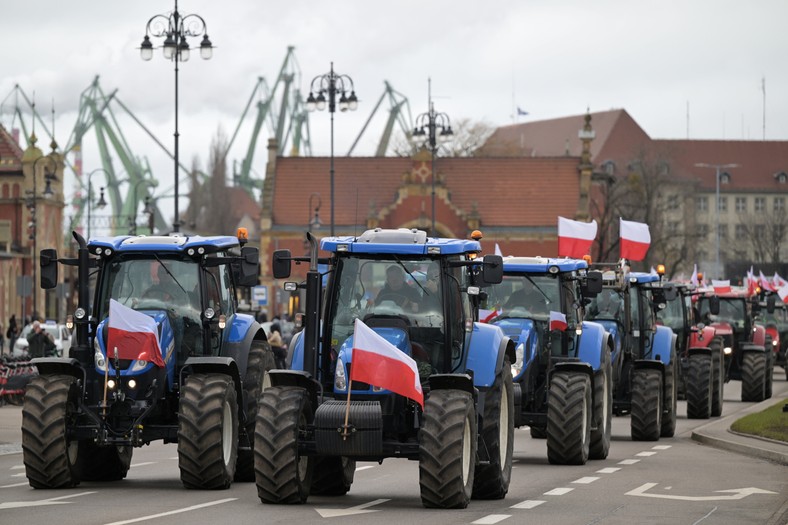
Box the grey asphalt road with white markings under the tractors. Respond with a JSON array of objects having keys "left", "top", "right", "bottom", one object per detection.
[{"left": 0, "top": 369, "right": 788, "bottom": 525}]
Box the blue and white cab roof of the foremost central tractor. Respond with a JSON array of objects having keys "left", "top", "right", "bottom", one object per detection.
[{"left": 320, "top": 228, "right": 482, "bottom": 255}]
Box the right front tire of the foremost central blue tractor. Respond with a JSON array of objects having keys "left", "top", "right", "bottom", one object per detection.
[{"left": 419, "top": 390, "right": 478, "bottom": 509}]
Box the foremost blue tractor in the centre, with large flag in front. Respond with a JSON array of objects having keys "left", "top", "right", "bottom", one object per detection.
[{"left": 255, "top": 228, "right": 515, "bottom": 508}]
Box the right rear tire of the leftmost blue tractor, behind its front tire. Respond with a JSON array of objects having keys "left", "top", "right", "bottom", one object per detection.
[{"left": 235, "top": 340, "right": 276, "bottom": 482}]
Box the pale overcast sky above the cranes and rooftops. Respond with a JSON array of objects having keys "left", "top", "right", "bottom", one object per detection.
[{"left": 0, "top": 0, "right": 788, "bottom": 228}]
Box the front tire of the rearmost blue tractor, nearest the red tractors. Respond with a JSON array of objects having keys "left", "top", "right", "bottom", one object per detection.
[{"left": 630, "top": 368, "right": 664, "bottom": 441}]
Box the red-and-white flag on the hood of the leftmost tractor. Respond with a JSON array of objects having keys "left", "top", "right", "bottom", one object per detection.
[{"left": 107, "top": 299, "right": 164, "bottom": 367}]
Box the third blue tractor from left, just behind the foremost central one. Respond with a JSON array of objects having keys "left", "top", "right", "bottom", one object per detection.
[{"left": 482, "top": 257, "right": 613, "bottom": 465}]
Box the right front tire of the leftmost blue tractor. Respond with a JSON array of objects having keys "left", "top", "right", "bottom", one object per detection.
[{"left": 178, "top": 374, "right": 238, "bottom": 489}]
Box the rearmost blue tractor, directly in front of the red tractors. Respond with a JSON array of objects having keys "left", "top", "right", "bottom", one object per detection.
[{"left": 586, "top": 260, "right": 678, "bottom": 441}]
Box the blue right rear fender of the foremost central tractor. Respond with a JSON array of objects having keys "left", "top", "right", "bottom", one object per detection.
[{"left": 465, "top": 322, "right": 515, "bottom": 388}]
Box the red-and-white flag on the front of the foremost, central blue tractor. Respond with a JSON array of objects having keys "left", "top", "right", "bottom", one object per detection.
[{"left": 350, "top": 318, "right": 424, "bottom": 408}]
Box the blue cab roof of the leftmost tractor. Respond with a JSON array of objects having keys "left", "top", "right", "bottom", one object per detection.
[{"left": 88, "top": 235, "right": 240, "bottom": 255}]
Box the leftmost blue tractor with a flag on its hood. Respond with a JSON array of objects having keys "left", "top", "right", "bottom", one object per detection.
[{"left": 22, "top": 230, "right": 274, "bottom": 489}]
